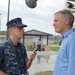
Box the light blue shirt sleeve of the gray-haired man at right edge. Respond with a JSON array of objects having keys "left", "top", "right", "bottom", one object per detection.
[{"left": 68, "top": 40, "right": 75, "bottom": 75}]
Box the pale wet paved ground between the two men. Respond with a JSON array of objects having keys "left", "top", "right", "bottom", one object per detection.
[{"left": 28, "top": 51, "right": 57, "bottom": 75}]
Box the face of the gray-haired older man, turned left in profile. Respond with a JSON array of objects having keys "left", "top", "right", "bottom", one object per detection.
[{"left": 53, "top": 14, "right": 67, "bottom": 34}]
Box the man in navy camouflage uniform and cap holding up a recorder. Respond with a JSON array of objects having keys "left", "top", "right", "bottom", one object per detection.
[{"left": 0, "top": 18, "right": 37, "bottom": 75}]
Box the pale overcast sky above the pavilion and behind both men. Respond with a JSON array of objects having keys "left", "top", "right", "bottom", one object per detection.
[{"left": 0, "top": 0, "right": 66, "bottom": 34}]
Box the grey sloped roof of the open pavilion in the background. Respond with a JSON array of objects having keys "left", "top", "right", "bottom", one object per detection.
[{"left": 24, "top": 29, "right": 53, "bottom": 36}]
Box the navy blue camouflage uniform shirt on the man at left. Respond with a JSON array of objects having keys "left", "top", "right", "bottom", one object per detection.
[{"left": 0, "top": 41, "right": 28, "bottom": 75}]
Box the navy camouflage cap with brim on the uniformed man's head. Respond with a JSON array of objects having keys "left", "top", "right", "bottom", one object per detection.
[{"left": 6, "top": 18, "right": 27, "bottom": 28}]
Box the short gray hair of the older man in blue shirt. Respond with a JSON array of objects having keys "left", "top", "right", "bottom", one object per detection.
[{"left": 55, "top": 9, "right": 74, "bottom": 26}]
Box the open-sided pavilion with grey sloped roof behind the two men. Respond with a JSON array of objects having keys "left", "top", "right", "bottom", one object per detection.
[{"left": 21, "top": 29, "right": 53, "bottom": 50}]
